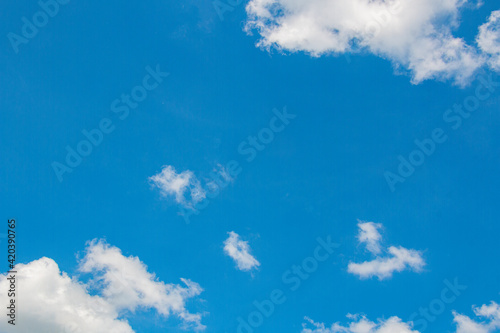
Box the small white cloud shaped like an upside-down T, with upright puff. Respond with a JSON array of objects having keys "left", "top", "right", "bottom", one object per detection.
[{"left": 347, "top": 222, "right": 425, "bottom": 280}]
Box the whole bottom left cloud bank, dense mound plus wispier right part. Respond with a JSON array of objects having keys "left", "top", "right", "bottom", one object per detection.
[{"left": 0, "top": 241, "right": 204, "bottom": 333}]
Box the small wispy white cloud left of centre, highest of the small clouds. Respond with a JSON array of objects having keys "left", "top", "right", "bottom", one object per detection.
[{"left": 149, "top": 165, "right": 206, "bottom": 208}]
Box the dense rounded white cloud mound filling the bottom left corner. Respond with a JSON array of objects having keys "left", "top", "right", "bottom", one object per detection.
[{"left": 0, "top": 257, "right": 134, "bottom": 333}]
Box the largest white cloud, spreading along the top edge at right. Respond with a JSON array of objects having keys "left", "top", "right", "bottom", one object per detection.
[{"left": 246, "top": 0, "right": 498, "bottom": 85}]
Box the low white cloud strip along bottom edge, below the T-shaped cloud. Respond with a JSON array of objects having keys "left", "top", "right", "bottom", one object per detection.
[{"left": 302, "top": 315, "right": 418, "bottom": 333}]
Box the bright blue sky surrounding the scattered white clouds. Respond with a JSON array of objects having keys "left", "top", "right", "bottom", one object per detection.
[{"left": 0, "top": 0, "right": 500, "bottom": 333}]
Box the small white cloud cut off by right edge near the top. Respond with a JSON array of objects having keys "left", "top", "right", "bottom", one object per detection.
[{"left": 477, "top": 10, "right": 500, "bottom": 70}]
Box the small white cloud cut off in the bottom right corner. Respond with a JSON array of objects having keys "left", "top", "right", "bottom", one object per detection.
[{"left": 453, "top": 302, "right": 500, "bottom": 333}]
